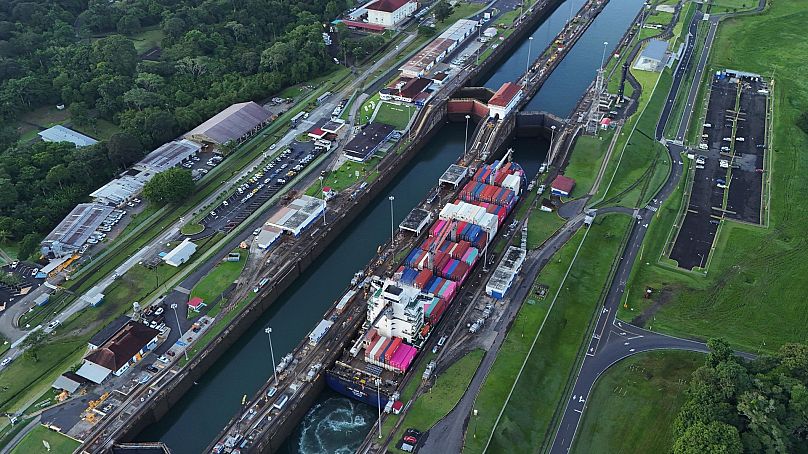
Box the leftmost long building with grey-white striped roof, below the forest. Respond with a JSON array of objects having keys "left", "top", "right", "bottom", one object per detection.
[{"left": 40, "top": 203, "right": 113, "bottom": 258}]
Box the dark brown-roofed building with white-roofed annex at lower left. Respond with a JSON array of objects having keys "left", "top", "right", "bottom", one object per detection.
[{"left": 76, "top": 321, "right": 160, "bottom": 383}]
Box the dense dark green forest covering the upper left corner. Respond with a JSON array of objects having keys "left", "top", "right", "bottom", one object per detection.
[{"left": 0, "top": 0, "right": 354, "bottom": 255}]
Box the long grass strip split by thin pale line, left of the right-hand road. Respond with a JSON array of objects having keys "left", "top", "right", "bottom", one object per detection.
[{"left": 465, "top": 215, "right": 631, "bottom": 453}]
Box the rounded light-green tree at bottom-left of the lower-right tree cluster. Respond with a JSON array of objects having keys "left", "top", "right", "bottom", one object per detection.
[{"left": 673, "top": 421, "right": 743, "bottom": 454}]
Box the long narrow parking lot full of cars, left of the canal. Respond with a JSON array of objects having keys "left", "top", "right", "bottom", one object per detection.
[{"left": 201, "top": 141, "right": 325, "bottom": 232}]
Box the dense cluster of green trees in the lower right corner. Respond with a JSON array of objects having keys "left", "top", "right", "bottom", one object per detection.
[{"left": 673, "top": 340, "right": 808, "bottom": 454}]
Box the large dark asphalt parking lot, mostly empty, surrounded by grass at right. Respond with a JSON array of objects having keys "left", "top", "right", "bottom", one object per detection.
[{"left": 670, "top": 71, "right": 768, "bottom": 269}]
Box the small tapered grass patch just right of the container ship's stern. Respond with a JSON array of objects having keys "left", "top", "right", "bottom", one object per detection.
[{"left": 390, "top": 349, "right": 485, "bottom": 452}]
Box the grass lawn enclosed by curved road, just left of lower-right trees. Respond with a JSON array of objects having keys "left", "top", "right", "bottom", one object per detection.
[{"left": 572, "top": 351, "right": 704, "bottom": 454}]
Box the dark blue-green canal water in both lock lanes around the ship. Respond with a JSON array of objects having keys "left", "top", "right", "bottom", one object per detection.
[{"left": 137, "top": 0, "right": 642, "bottom": 454}]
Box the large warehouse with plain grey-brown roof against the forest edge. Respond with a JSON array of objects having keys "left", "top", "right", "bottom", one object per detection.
[{"left": 185, "top": 101, "right": 272, "bottom": 145}]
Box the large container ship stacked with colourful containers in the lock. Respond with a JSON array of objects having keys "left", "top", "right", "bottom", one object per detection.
[{"left": 326, "top": 155, "right": 525, "bottom": 407}]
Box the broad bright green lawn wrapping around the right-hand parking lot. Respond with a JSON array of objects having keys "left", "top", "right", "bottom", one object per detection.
[{"left": 612, "top": 2, "right": 808, "bottom": 352}]
